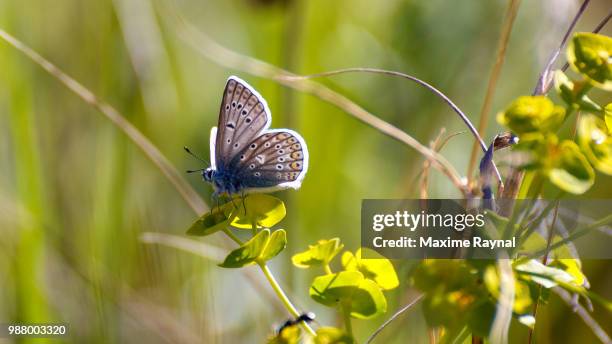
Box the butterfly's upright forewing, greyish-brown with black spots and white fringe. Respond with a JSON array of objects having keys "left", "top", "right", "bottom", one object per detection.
[{"left": 211, "top": 76, "right": 272, "bottom": 169}]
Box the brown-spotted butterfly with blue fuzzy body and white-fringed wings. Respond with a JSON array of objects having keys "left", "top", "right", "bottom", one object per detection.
[{"left": 186, "top": 76, "right": 308, "bottom": 196}]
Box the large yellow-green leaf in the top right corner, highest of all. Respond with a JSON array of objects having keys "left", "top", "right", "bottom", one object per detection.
[{"left": 567, "top": 32, "right": 612, "bottom": 91}]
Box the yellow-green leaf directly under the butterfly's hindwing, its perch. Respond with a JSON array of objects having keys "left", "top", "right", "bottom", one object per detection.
[{"left": 232, "top": 194, "right": 287, "bottom": 228}]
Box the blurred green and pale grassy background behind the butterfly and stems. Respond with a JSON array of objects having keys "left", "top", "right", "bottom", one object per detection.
[{"left": 0, "top": 0, "right": 612, "bottom": 343}]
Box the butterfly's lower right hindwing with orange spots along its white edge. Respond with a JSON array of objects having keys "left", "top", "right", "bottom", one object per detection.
[{"left": 230, "top": 129, "right": 308, "bottom": 193}]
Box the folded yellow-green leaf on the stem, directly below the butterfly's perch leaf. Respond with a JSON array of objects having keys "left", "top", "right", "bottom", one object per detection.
[{"left": 219, "top": 228, "right": 287, "bottom": 268}]
